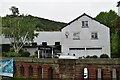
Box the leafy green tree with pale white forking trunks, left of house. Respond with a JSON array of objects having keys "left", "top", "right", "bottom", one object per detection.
[{"left": 2, "top": 8, "right": 39, "bottom": 53}]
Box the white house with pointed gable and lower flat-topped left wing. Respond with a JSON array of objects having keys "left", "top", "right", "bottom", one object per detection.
[{"left": 34, "top": 13, "right": 110, "bottom": 57}]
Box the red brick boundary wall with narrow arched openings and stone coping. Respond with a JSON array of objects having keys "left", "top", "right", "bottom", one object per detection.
[{"left": 3, "top": 58, "right": 120, "bottom": 80}]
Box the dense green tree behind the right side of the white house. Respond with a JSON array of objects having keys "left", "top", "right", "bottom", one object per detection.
[{"left": 96, "top": 10, "right": 118, "bottom": 55}]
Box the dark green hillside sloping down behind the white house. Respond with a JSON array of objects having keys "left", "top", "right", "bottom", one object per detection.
[{"left": 2, "top": 15, "right": 66, "bottom": 31}]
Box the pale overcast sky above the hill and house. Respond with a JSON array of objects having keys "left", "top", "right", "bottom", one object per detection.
[{"left": 0, "top": 0, "right": 119, "bottom": 23}]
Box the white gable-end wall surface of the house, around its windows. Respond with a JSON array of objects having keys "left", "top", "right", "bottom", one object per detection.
[{"left": 61, "top": 16, "right": 110, "bottom": 57}]
